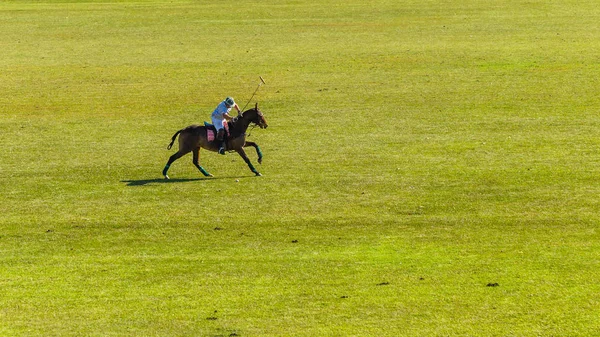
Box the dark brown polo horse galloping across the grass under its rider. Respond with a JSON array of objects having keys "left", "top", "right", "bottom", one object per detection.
[{"left": 163, "top": 103, "right": 268, "bottom": 179}]
